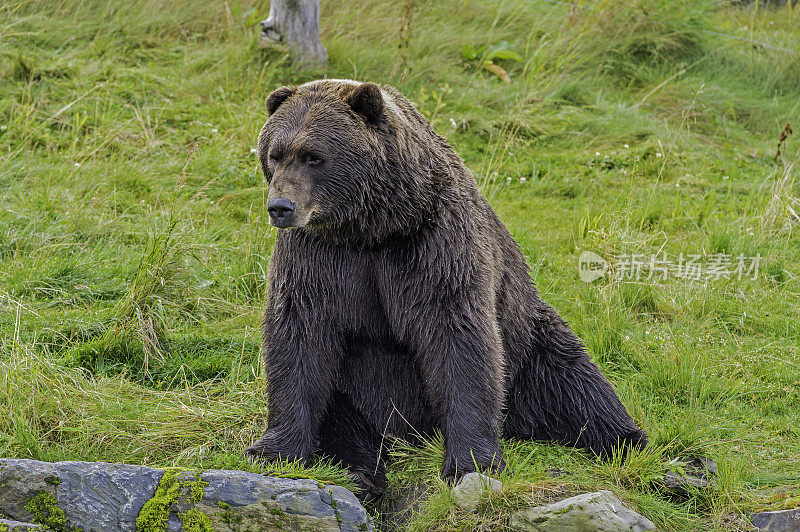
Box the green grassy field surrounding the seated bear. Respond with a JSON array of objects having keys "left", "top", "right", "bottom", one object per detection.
[{"left": 0, "top": 0, "right": 800, "bottom": 530}]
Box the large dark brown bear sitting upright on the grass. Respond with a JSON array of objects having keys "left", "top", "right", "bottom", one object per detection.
[{"left": 246, "top": 79, "right": 647, "bottom": 498}]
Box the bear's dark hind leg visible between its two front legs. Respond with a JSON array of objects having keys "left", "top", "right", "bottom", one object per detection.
[{"left": 317, "top": 392, "right": 386, "bottom": 502}]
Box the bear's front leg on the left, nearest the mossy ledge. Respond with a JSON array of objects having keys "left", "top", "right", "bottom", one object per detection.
[{"left": 245, "top": 309, "right": 341, "bottom": 461}]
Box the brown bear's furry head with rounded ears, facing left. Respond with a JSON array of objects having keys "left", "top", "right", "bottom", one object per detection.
[{"left": 258, "top": 80, "right": 446, "bottom": 243}]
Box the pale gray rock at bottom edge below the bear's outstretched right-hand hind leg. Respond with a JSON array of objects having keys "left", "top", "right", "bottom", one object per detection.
[{"left": 511, "top": 490, "right": 656, "bottom": 532}]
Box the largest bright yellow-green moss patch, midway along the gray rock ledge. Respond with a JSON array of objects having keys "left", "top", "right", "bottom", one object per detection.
[{"left": 136, "top": 469, "right": 213, "bottom": 532}]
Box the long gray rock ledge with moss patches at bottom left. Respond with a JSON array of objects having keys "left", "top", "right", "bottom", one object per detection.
[{"left": 0, "top": 459, "right": 374, "bottom": 532}]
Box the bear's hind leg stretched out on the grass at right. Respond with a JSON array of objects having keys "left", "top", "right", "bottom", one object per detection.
[{"left": 503, "top": 316, "right": 647, "bottom": 457}]
